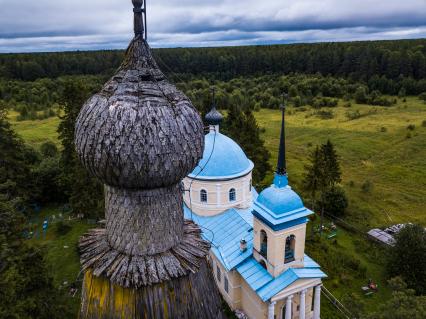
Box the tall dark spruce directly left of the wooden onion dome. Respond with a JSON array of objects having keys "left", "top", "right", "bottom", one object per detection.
[{"left": 58, "top": 80, "right": 103, "bottom": 217}]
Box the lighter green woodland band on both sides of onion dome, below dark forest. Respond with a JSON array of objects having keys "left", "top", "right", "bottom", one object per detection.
[{"left": 4, "top": 74, "right": 426, "bottom": 124}]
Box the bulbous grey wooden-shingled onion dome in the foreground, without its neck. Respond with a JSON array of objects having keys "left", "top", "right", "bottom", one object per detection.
[{"left": 75, "top": 29, "right": 204, "bottom": 189}]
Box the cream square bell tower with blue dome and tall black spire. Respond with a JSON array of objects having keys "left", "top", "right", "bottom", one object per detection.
[{"left": 253, "top": 96, "right": 312, "bottom": 276}]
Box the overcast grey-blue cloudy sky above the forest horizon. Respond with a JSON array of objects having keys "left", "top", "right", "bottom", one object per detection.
[{"left": 0, "top": 0, "right": 426, "bottom": 52}]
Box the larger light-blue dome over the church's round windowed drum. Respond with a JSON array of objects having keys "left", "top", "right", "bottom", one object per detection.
[{"left": 188, "top": 131, "right": 254, "bottom": 180}]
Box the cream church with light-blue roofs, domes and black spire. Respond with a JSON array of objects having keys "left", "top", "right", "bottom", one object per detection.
[{"left": 184, "top": 102, "right": 326, "bottom": 319}]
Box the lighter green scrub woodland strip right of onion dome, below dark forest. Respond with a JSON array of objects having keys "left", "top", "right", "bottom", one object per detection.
[{"left": 183, "top": 74, "right": 410, "bottom": 113}]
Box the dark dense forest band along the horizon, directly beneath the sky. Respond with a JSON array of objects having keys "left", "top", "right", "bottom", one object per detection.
[{"left": 0, "top": 39, "right": 426, "bottom": 94}]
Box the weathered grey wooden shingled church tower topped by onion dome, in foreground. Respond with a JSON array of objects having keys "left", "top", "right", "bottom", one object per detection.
[{"left": 75, "top": 0, "right": 226, "bottom": 318}]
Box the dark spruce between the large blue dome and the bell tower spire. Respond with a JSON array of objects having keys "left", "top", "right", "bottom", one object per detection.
[{"left": 223, "top": 104, "right": 272, "bottom": 186}]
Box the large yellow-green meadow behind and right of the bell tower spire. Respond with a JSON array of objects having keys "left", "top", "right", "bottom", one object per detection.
[{"left": 256, "top": 98, "right": 426, "bottom": 229}]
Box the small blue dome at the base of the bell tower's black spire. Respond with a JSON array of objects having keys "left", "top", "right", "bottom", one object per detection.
[{"left": 257, "top": 185, "right": 304, "bottom": 215}]
